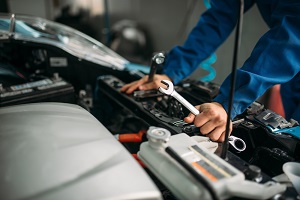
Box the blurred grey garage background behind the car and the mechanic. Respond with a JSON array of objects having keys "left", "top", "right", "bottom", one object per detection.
[{"left": 0, "top": 0, "right": 267, "bottom": 84}]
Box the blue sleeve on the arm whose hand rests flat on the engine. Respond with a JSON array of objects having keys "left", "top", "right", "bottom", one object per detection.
[{"left": 164, "top": 0, "right": 239, "bottom": 84}]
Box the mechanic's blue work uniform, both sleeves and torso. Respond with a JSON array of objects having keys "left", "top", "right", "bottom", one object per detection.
[{"left": 164, "top": 0, "right": 300, "bottom": 122}]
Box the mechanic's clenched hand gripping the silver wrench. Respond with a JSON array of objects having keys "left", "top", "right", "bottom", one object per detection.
[{"left": 184, "top": 102, "right": 232, "bottom": 142}]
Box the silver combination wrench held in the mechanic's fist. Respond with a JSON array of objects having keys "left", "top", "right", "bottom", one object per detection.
[{"left": 158, "top": 80, "right": 246, "bottom": 151}]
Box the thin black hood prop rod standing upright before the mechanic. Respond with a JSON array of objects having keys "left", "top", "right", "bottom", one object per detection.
[{"left": 221, "top": 0, "right": 244, "bottom": 159}]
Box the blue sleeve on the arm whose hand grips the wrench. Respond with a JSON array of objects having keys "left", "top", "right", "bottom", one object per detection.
[{"left": 214, "top": 0, "right": 300, "bottom": 119}]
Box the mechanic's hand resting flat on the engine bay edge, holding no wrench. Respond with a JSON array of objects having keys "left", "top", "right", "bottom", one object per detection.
[{"left": 121, "top": 74, "right": 171, "bottom": 94}]
